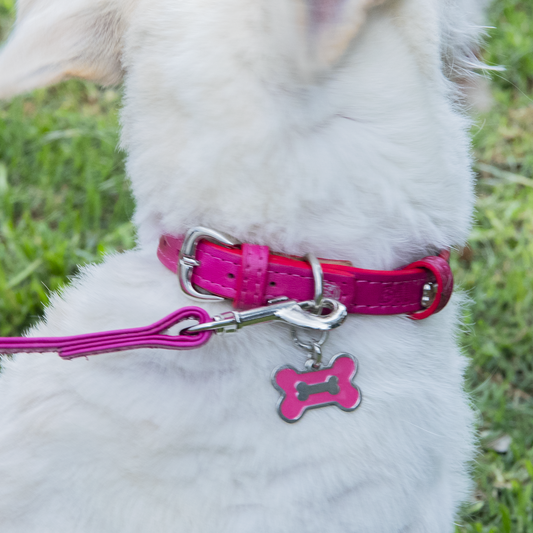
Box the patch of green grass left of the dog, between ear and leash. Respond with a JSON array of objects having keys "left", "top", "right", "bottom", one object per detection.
[{"left": 0, "top": 81, "right": 133, "bottom": 336}]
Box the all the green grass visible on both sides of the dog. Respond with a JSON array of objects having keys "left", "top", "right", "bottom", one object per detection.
[{"left": 0, "top": 0, "right": 533, "bottom": 533}]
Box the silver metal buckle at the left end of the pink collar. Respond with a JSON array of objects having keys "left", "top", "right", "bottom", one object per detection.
[{"left": 178, "top": 226, "right": 241, "bottom": 302}]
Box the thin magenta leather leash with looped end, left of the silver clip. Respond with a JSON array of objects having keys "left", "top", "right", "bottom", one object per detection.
[{"left": 0, "top": 307, "right": 212, "bottom": 359}]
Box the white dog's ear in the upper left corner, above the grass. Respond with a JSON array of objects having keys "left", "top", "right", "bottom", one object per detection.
[{"left": 0, "top": 0, "right": 133, "bottom": 98}]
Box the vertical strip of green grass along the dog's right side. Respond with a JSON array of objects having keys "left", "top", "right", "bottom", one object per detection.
[{"left": 455, "top": 0, "right": 533, "bottom": 533}]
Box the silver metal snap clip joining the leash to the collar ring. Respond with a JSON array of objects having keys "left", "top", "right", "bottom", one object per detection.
[{"left": 181, "top": 298, "right": 348, "bottom": 334}]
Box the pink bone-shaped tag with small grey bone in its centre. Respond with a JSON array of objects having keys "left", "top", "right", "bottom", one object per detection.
[{"left": 272, "top": 353, "right": 361, "bottom": 423}]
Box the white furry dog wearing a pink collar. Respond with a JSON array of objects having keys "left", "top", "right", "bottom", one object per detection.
[{"left": 0, "top": 0, "right": 486, "bottom": 533}]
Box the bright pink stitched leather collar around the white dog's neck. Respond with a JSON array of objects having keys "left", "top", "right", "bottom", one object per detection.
[{"left": 157, "top": 235, "right": 453, "bottom": 320}]
